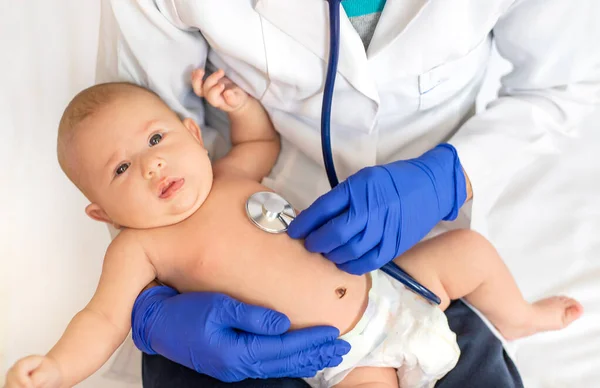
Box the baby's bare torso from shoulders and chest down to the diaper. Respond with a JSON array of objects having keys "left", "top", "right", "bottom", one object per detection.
[{"left": 153, "top": 181, "right": 370, "bottom": 333}]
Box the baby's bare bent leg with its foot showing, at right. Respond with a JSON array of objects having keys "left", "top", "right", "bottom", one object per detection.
[{"left": 394, "top": 230, "right": 583, "bottom": 339}]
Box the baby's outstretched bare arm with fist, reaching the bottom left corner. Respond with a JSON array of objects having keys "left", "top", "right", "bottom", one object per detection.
[{"left": 6, "top": 233, "right": 156, "bottom": 388}]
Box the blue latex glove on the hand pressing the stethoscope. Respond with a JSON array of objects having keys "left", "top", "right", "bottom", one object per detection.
[{"left": 288, "top": 144, "right": 467, "bottom": 275}]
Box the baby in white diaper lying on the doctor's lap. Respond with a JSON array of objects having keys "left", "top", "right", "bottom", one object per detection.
[{"left": 7, "top": 70, "right": 583, "bottom": 388}]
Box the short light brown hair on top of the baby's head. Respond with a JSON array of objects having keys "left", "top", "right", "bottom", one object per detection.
[{"left": 56, "top": 82, "right": 160, "bottom": 194}]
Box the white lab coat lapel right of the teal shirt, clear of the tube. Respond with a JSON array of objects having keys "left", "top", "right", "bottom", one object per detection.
[{"left": 367, "top": 0, "right": 430, "bottom": 59}]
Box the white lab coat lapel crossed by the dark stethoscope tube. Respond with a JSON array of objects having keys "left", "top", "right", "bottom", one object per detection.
[{"left": 254, "top": 0, "right": 379, "bottom": 103}]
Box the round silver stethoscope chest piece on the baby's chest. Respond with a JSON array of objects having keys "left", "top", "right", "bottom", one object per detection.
[{"left": 246, "top": 191, "right": 296, "bottom": 233}]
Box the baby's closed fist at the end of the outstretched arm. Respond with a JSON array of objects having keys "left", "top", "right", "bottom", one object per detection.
[{"left": 4, "top": 356, "right": 62, "bottom": 388}]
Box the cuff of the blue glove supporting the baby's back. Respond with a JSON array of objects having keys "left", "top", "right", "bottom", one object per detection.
[{"left": 131, "top": 286, "right": 178, "bottom": 355}]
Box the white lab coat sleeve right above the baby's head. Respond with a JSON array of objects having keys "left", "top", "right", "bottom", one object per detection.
[{"left": 96, "top": 0, "right": 227, "bottom": 155}]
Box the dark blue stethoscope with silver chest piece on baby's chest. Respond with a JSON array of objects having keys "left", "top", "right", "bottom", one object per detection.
[{"left": 246, "top": 0, "right": 441, "bottom": 304}]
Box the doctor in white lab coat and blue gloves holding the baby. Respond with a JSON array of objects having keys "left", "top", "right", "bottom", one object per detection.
[{"left": 97, "top": 0, "right": 600, "bottom": 387}]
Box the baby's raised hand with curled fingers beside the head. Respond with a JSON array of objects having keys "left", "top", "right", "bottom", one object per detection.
[{"left": 192, "top": 69, "right": 248, "bottom": 113}]
